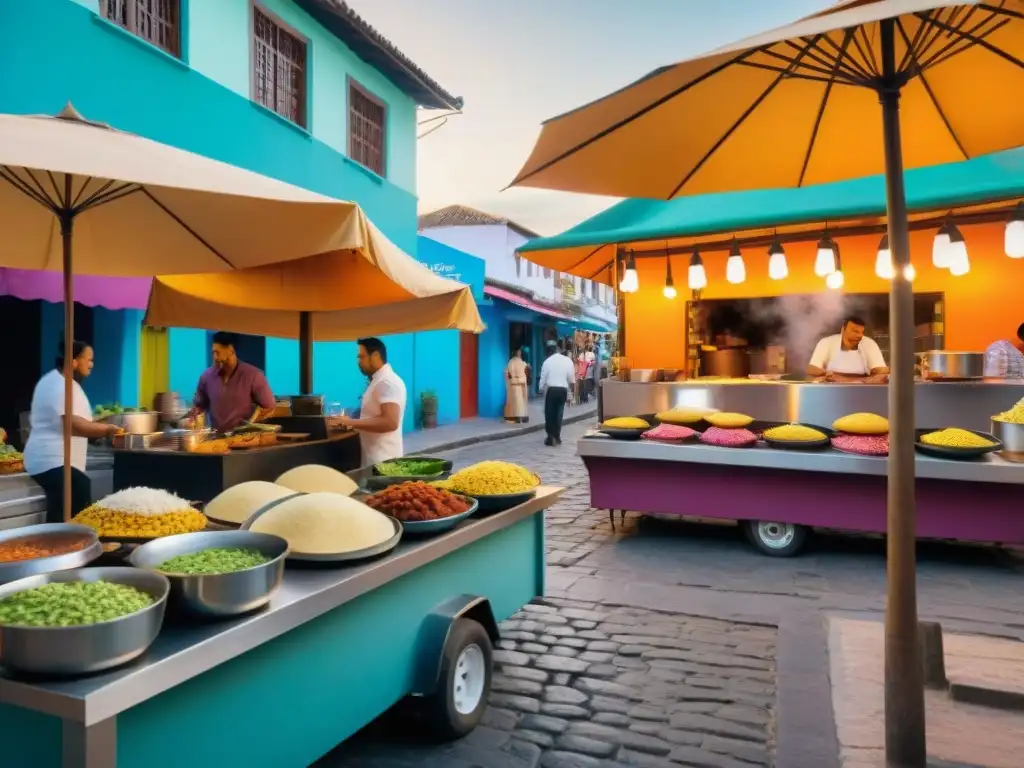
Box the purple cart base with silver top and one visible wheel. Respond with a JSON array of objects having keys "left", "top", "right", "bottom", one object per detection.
[{"left": 579, "top": 436, "right": 1024, "bottom": 556}]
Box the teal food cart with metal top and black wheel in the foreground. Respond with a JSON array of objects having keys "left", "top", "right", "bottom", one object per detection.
[{"left": 0, "top": 486, "right": 561, "bottom": 768}]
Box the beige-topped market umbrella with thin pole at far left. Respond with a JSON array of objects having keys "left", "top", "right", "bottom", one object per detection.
[{"left": 0, "top": 105, "right": 399, "bottom": 517}]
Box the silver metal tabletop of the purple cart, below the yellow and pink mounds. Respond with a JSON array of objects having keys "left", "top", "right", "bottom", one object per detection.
[{"left": 578, "top": 437, "right": 1024, "bottom": 484}]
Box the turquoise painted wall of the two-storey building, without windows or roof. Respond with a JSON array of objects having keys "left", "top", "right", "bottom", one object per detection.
[{"left": 0, "top": 0, "right": 440, "bottom": 428}]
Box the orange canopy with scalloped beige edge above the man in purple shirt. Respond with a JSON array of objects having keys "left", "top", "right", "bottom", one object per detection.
[{"left": 145, "top": 212, "right": 484, "bottom": 393}]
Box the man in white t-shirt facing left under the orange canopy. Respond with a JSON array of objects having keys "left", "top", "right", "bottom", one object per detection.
[{"left": 330, "top": 338, "right": 406, "bottom": 467}]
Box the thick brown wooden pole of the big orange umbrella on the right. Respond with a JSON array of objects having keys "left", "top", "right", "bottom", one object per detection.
[{"left": 879, "top": 18, "right": 928, "bottom": 768}]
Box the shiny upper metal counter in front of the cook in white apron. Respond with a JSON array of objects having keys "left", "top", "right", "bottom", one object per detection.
[{"left": 598, "top": 379, "right": 1024, "bottom": 432}]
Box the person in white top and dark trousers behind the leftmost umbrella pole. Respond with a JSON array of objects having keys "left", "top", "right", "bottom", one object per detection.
[{"left": 25, "top": 341, "right": 120, "bottom": 522}]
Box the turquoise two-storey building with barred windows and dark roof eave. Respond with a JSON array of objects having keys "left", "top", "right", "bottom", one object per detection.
[{"left": 0, "top": 0, "right": 461, "bottom": 428}]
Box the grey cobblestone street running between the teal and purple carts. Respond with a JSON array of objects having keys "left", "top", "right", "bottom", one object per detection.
[{"left": 317, "top": 424, "right": 1024, "bottom": 768}]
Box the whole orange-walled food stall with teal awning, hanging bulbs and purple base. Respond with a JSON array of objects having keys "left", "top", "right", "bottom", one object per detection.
[{"left": 522, "top": 150, "right": 1024, "bottom": 555}]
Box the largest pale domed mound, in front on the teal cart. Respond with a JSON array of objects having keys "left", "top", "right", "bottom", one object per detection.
[{"left": 250, "top": 493, "right": 395, "bottom": 555}]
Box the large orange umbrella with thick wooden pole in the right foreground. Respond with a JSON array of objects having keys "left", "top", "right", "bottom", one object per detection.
[{"left": 512, "top": 0, "right": 1024, "bottom": 766}]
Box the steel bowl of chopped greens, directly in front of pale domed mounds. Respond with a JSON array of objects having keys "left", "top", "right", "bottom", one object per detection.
[{"left": 128, "top": 530, "right": 288, "bottom": 616}]
